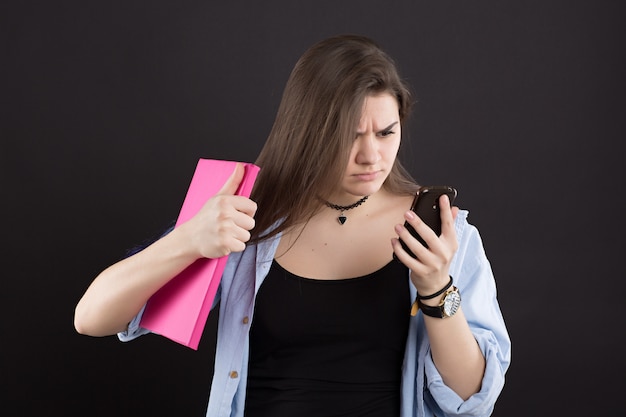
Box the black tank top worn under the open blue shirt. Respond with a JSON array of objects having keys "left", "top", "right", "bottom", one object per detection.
[{"left": 245, "top": 261, "right": 411, "bottom": 417}]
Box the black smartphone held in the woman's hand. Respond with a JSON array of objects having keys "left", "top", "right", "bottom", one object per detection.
[{"left": 394, "top": 185, "right": 456, "bottom": 258}]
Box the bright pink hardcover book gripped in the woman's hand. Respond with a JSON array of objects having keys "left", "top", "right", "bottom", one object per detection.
[{"left": 141, "top": 159, "right": 259, "bottom": 350}]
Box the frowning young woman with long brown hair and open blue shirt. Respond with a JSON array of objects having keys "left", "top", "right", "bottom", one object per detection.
[{"left": 75, "top": 35, "right": 510, "bottom": 417}]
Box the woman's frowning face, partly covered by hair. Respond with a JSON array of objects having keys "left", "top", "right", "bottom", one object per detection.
[{"left": 331, "top": 93, "right": 401, "bottom": 204}]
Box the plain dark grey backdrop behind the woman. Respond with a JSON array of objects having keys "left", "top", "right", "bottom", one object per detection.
[{"left": 0, "top": 0, "right": 626, "bottom": 417}]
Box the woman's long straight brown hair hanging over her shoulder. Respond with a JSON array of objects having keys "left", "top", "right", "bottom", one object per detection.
[{"left": 251, "top": 35, "right": 417, "bottom": 242}]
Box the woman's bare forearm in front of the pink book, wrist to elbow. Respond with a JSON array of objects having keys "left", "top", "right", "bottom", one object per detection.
[{"left": 74, "top": 226, "right": 198, "bottom": 336}]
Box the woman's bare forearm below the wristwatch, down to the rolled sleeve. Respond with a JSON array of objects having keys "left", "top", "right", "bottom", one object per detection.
[{"left": 424, "top": 308, "right": 485, "bottom": 400}]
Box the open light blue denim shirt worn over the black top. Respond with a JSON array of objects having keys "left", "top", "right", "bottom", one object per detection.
[{"left": 118, "top": 210, "right": 511, "bottom": 417}]
